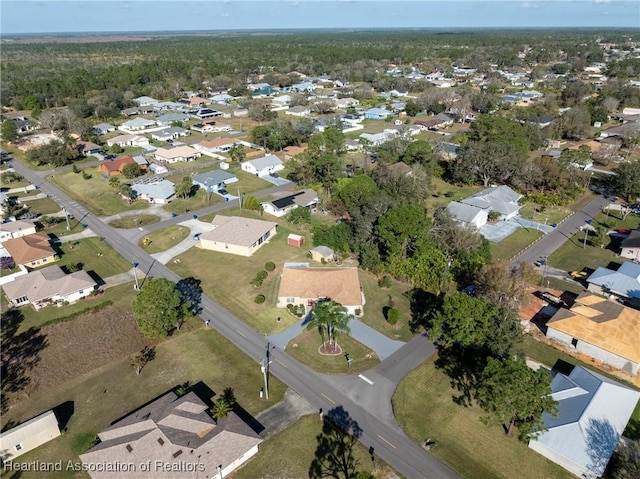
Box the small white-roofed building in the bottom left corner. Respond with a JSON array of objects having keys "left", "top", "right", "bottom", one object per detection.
[{"left": 0, "top": 411, "right": 60, "bottom": 464}]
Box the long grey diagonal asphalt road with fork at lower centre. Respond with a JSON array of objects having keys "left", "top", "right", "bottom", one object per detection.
[{"left": 12, "top": 160, "right": 459, "bottom": 479}]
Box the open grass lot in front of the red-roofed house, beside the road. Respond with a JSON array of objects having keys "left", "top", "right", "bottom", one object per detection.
[{"left": 51, "top": 168, "right": 149, "bottom": 216}]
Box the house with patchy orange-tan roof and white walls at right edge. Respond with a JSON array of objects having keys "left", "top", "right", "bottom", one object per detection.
[{"left": 546, "top": 293, "right": 640, "bottom": 375}]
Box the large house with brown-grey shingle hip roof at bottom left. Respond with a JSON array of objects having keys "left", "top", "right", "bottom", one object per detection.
[{"left": 80, "top": 392, "right": 263, "bottom": 479}]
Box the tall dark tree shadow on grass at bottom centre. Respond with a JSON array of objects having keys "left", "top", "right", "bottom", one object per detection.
[{"left": 309, "top": 406, "right": 362, "bottom": 479}]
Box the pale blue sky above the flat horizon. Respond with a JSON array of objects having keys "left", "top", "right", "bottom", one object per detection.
[{"left": 0, "top": 0, "right": 640, "bottom": 35}]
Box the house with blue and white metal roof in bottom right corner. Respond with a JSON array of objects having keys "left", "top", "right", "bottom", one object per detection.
[{"left": 529, "top": 366, "right": 640, "bottom": 479}]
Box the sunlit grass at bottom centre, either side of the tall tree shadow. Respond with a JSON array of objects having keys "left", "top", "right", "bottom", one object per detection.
[{"left": 231, "top": 415, "right": 398, "bottom": 479}]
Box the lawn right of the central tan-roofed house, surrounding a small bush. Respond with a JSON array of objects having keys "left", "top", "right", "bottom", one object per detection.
[{"left": 359, "top": 270, "right": 413, "bottom": 341}]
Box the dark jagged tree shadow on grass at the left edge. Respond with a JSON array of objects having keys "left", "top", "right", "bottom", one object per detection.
[{"left": 0, "top": 309, "right": 48, "bottom": 412}]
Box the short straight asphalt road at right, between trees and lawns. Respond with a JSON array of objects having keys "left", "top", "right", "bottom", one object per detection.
[{"left": 511, "top": 196, "right": 611, "bottom": 263}]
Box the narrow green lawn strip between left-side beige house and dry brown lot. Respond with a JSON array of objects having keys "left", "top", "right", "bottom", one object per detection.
[{"left": 17, "top": 283, "right": 134, "bottom": 334}]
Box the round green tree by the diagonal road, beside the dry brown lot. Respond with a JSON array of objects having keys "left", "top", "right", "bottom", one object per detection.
[{"left": 133, "top": 278, "right": 190, "bottom": 338}]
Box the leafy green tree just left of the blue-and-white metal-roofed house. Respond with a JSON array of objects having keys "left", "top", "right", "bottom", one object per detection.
[{"left": 476, "top": 358, "right": 558, "bottom": 439}]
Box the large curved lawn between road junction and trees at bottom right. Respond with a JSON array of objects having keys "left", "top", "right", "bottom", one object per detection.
[{"left": 393, "top": 360, "right": 573, "bottom": 479}]
